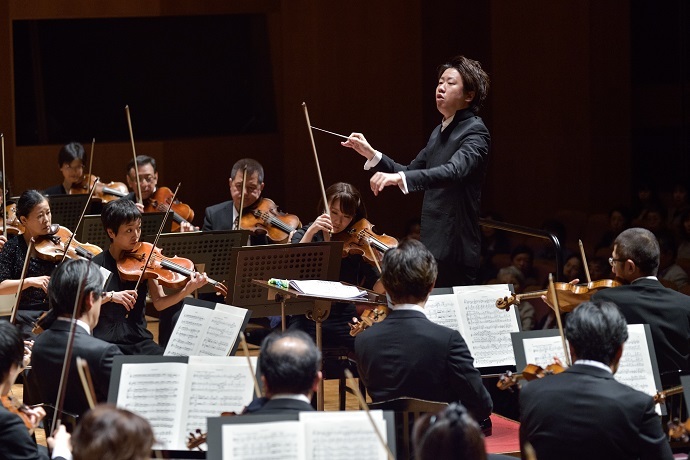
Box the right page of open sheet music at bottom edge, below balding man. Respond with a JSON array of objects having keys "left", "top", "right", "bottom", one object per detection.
[{"left": 300, "top": 411, "right": 388, "bottom": 460}]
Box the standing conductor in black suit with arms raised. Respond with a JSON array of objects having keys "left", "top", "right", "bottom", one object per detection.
[{"left": 342, "top": 56, "right": 490, "bottom": 287}]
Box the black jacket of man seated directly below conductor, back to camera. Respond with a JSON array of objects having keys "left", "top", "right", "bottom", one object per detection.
[{"left": 355, "top": 310, "right": 492, "bottom": 420}]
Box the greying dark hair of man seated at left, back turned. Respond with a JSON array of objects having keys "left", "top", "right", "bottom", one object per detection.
[{"left": 48, "top": 259, "right": 103, "bottom": 318}]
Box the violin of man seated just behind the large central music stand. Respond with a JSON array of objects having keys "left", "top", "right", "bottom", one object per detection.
[{"left": 240, "top": 198, "right": 302, "bottom": 243}]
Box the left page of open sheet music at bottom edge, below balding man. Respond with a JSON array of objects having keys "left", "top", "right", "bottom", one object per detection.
[{"left": 222, "top": 421, "right": 304, "bottom": 460}]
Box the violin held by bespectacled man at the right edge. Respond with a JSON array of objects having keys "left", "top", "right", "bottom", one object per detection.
[{"left": 496, "top": 279, "right": 622, "bottom": 313}]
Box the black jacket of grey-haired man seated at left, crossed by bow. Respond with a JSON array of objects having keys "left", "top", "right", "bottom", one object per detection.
[{"left": 25, "top": 320, "right": 122, "bottom": 416}]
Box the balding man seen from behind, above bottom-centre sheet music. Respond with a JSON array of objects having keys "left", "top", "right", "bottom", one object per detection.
[{"left": 245, "top": 329, "right": 322, "bottom": 414}]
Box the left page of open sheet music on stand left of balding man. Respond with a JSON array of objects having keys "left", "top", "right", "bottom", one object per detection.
[{"left": 117, "top": 363, "right": 187, "bottom": 449}]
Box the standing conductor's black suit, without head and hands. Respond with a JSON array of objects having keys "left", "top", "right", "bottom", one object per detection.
[{"left": 374, "top": 109, "right": 490, "bottom": 287}]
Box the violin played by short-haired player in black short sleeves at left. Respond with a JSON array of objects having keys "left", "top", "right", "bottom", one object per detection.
[{"left": 117, "top": 241, "right": 228, "bottom": 297}]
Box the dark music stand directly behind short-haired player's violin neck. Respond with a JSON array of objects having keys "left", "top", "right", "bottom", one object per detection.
[{"left": 158, "top": 230, "right": 251, "bottom": 293}]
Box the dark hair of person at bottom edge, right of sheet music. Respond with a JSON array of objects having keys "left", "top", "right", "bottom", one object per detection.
[{"left": 412, "top": 402, "right": 487, "bottom": 460}]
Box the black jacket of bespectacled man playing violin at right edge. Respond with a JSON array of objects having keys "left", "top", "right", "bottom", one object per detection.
[{"left": 592, "top": 278, "right": 690, "bottom": 387}]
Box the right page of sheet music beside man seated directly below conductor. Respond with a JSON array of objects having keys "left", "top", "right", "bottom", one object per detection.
[{"left": 453, "top": 284, "right": 520, "bottom": 367}]
